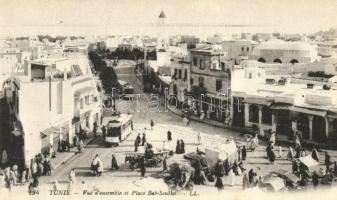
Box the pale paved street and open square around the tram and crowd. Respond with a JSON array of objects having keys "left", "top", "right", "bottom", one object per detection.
[{"left": 30, "top": 63, "right": 336, "bottom": 195}]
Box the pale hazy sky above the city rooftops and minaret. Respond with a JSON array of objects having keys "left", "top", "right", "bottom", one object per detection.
[{"left": 0, "top": 0, "right": 337, "bottom": 34}]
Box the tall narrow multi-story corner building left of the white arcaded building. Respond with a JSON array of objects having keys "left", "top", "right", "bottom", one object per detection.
[{"left": 190, "top": 47, "right": 233, "bottom": 122}]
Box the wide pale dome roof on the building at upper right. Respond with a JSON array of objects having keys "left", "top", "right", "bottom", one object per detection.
[{"left": 256, "top": 40, "right": 315, "bottom": 51}]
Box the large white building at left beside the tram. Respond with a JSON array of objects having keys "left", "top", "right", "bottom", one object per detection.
[{"left": 5, "top": 54, "right": 101, "bottom": 164}]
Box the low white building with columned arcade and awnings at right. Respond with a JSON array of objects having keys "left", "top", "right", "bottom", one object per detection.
[{"left": 231, "top": 61, "right": 337, "bottom": 142}]
